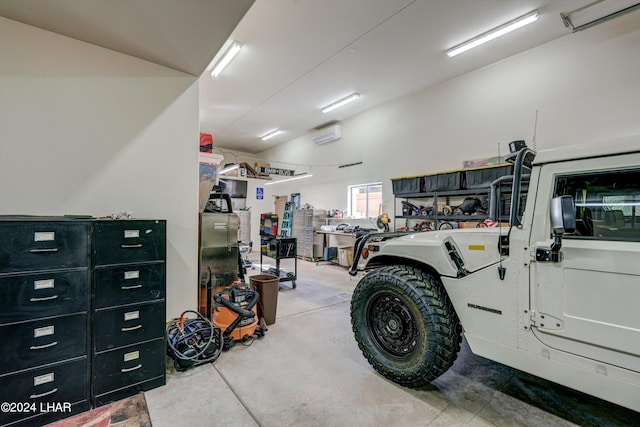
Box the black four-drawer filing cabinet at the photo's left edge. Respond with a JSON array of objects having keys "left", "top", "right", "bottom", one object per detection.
[{"left": 0, "top": 217, "right": 91, "bottom": 426}]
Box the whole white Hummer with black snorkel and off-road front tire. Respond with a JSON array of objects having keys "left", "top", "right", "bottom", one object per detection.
[{"left": 349, "top": 137, "right": 640, "bottom": 411}]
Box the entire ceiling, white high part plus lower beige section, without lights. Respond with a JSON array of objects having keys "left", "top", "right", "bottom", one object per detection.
[{"left": 0, "top": 0, "right": 640, "bottom": 153}]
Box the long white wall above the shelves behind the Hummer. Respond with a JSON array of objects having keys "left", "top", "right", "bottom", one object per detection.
[{"left": 252, "top": 13, "right": 640, "bottom": 229}]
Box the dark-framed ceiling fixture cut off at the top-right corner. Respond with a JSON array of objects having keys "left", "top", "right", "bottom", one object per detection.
[{"left": 560, "top": 0, "right": 640, "bottom": 33}]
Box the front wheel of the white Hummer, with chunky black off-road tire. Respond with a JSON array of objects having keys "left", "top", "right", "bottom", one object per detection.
[{"left": 351, "top": 265, "right": 461, "bottom": 387}]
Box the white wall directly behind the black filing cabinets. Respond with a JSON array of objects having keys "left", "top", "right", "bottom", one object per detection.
[{"left": 0, "top": 17, "right": 199, "bottom": 317}]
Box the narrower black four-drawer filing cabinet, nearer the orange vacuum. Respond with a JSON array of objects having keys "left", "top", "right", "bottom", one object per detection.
[{"left": 91, "top": 220, "right": 166, "bottom": 406}]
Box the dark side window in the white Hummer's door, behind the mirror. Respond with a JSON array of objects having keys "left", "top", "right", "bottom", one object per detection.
[{"left": 554, "top": 169, "right": 640, "bottom": 241}]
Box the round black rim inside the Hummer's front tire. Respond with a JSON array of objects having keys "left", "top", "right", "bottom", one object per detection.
[{"left": 367, "top": 293, "right": 418, "bottom": 356}]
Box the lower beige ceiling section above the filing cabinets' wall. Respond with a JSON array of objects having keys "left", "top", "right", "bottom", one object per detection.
[{"left": 0, "top": 0, "right": 254, "bottom": 76}]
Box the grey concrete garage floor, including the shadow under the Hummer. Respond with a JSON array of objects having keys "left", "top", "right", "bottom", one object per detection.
[{"left": 145, "top": 260, "right": 640, "bottom": 427}]
